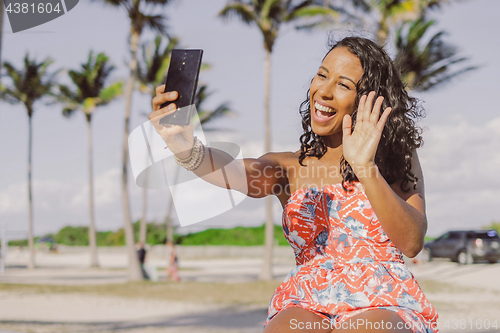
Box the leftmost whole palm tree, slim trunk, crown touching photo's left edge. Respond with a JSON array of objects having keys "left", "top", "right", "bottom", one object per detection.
[{"left": 0, "top": 53, "right": 57, "bottom": 269}]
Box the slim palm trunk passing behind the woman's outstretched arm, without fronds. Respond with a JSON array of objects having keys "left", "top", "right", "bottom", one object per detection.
[{"left": 260, "top": 48, "right": 274, "bottom": 280}]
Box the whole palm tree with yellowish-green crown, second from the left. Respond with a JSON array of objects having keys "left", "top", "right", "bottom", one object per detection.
[{"left": 58, "top": 51, "right": 122, "bottom": 267}]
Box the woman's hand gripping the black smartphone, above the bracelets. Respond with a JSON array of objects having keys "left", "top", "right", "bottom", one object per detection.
[{"left": 149, "top": 85, "right": 194, "bottom": 158}]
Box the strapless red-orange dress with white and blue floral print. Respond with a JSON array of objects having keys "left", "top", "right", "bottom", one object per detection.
[{"left": 265, "top": 181, "right": 438, "bottom": 333}]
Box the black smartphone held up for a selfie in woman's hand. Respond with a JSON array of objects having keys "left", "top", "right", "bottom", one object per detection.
[{"left": 160, "top": 49, "right": 203, "bottom": 126}]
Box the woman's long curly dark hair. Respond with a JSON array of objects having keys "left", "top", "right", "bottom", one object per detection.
[{"left": 299, "top": 37, "right": 424, "bottom": 192}]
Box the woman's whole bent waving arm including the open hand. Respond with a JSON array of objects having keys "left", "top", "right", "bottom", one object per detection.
[{"left": 342, "top": 91, "right": 427, "bottom": 257}]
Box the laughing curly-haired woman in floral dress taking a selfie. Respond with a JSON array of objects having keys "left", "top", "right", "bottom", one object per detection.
[{"left": 149, "top": 37, "right": 438, "bottom": 333}]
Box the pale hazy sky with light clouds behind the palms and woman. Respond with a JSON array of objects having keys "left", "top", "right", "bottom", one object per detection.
[{"left": 0, "top": 0, "right": 500, "bottom": 239}]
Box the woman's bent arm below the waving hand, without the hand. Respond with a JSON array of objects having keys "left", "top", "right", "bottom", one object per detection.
[{"left": 354, "top": 152, "right": 427, "bottom": 258}]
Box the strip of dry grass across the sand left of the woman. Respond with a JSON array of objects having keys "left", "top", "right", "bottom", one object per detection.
[{"left": 0, "top": 280, "right": 282, "bottom": 305}]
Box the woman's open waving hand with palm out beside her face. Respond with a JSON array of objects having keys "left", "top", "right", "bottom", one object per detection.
[{"left": 342, "top": 91, "right": 392, "bottom": 178}]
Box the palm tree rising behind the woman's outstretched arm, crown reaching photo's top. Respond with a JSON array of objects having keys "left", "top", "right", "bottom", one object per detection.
[{"left": 219, "top": 0, "right": 337, "bottom": 280}]
